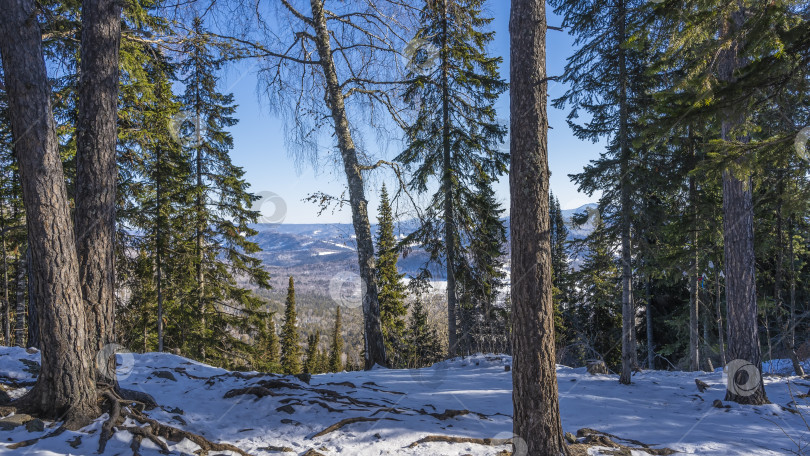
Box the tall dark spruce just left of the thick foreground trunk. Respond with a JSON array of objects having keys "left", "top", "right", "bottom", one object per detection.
[{"left": 397, "top": 0, "right": 508, "bottom": 356}]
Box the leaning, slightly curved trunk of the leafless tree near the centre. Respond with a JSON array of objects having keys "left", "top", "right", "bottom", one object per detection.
[{"left": 310, "top": 0, "right": 388, "bottom": 369}]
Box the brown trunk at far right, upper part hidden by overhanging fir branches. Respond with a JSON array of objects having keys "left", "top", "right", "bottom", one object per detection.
[{"left": 718, "top": 11, "right": 768, "bottom": 404}]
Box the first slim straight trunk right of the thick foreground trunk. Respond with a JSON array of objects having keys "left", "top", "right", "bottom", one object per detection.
[{"left": 618, "top": 0, "right": 638, "bottom": 385}]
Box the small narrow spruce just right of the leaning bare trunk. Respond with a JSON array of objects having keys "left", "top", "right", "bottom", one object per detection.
[{"left": 375, "top": 184, "right": 408, "bottom": 367}]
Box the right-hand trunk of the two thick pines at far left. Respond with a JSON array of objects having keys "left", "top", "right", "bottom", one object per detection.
[{"left": 74, "top": 0, "right": 122, "bottom": 382}]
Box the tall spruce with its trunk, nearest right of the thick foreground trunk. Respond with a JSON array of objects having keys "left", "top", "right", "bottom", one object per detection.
[{"left": 550, "top": 0, "right": 648, "bottom": 384}]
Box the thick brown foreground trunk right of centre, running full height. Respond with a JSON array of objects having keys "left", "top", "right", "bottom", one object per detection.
[{"left": 509, "top": 0, "right": 568, "bottom": 456}]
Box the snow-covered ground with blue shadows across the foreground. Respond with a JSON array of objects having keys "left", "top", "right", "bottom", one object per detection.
[{"left": 0, "top": 347, "right": 810, "bottom": 456}]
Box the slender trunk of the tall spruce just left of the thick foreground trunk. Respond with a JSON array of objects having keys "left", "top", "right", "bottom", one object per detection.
[{"left": 441, "top": 0, "right": 458, "bottom": 358}]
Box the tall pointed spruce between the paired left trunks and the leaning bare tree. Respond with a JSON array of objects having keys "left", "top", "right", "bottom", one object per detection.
[{"left": 175, "top": 18, "right": 270, "bottom": 360}]
